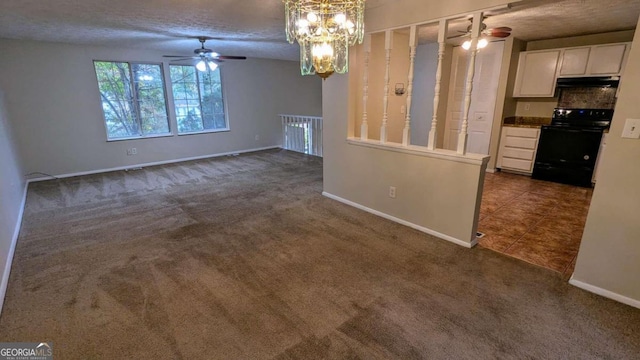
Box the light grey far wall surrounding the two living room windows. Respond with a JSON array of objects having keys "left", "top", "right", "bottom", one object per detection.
[{"left": 0, "top": 40, "right": 322, "bottom": 175}]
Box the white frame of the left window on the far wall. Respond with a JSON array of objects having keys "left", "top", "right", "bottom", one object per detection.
[{"left": 93, "top": 59, "right": 172, "bottom": 142}]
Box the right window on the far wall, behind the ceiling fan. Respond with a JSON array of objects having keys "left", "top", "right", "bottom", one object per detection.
[{"left": 169, "top": 65, "right": 229, "bottom": 134}]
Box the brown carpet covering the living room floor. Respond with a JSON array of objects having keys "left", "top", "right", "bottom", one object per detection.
[{"left": 0, "top": 151, "right": 640, "bottom": 359}]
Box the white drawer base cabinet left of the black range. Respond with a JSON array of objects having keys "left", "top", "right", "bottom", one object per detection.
[{"left": 496, "top": 126, "right": 540, "bottom": 175}]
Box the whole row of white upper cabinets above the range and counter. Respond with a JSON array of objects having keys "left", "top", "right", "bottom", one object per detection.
[{"left": 513, "top": 43, "right": 630, "bottom": 97}]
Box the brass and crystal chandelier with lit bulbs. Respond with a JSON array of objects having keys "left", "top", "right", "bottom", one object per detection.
[{"left": 283, "top": 0, "right": 365, "bottom": 79}]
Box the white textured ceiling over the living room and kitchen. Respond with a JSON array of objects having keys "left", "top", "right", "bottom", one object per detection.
[{"left": 0, "top": 0, "right": 640, "bottom": 60}]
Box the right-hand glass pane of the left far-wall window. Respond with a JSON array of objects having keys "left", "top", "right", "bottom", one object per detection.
[{"left": 132, "top": 64, "right": 169, "bottom": 135}]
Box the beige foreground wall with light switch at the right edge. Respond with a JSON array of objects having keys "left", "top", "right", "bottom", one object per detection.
[{"left": 572, "top": 21, "right": 640, "bottom": 307}]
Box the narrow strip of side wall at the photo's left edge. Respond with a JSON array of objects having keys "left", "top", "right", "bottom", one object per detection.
[{"left": 0, "top": 88, "right": 26, "bottom": 311}]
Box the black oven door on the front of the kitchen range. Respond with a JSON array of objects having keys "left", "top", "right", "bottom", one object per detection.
[{"left": 532, "top": 125, "right": 604, "bottom": 186}]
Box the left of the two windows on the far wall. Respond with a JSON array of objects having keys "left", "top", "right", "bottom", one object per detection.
[{"left": 94, "top": 61, "right": 169, "bottom": 140}]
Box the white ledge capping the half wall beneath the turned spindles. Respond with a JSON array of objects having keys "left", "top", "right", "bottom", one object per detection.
[{"left": 347, "top": 137, "right": 490, "bottom": 166}]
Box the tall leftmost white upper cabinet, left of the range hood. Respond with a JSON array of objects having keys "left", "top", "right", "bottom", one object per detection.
[{"left": 513, "top": 49, "right": 562, "bottom": 97}]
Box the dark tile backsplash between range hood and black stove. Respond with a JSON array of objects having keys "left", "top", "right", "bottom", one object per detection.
[{"left": 558, "top": 87, "right": 617, "bottom": 109}]
